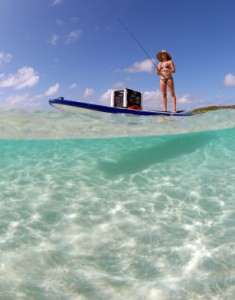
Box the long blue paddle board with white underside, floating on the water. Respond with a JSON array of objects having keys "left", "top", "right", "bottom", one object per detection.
[{"left": 49, "top": 97, "right": 193, "bottom": 117}]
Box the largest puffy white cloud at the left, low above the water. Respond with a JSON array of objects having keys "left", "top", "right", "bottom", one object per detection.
[{"left": 0, "top": 67, "right": 39, "bottom": 90}]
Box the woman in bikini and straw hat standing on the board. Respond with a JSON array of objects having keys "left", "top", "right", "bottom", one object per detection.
[{"left": 156, "top": 50, "right": 176, "bottom": 112}]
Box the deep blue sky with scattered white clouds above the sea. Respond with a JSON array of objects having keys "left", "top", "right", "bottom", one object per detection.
[{"left": 0, "top": 0, "right": 235, "bottom": 109}]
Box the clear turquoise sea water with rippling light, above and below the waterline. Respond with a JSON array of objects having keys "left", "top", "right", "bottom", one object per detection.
[{"left": 0, "top": 109, "right": 235, "bottom": 300}]
